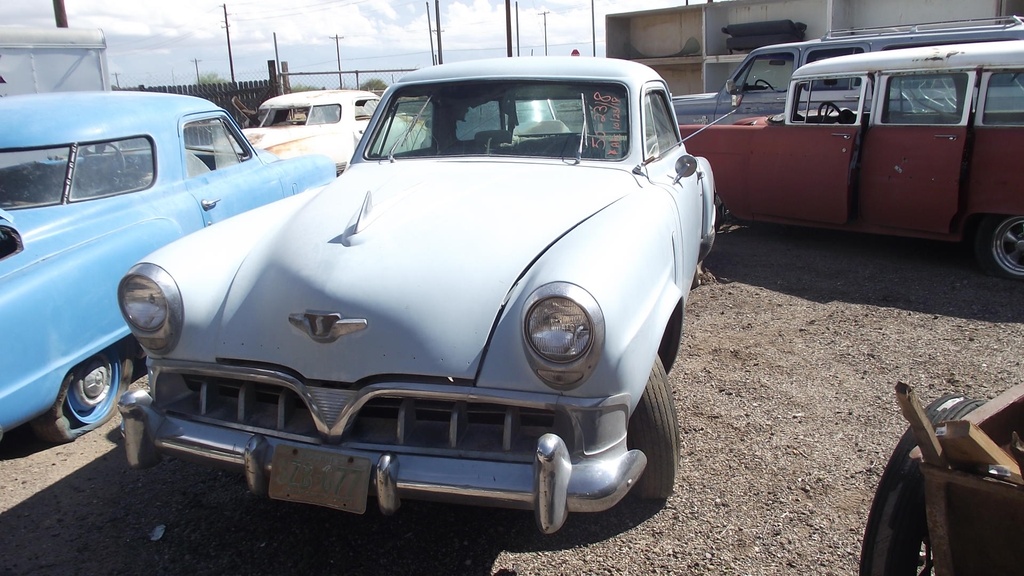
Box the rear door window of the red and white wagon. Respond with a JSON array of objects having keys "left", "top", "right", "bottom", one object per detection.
[{"left": 882, "top": 72, "right": 971, "bottom": 125}]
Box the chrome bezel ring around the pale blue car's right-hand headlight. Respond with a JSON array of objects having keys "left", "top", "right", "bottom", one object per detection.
[{"left": 520, "top": 282, "right": 605, "bottom": 390}]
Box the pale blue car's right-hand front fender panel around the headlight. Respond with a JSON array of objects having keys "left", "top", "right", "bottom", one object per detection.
[{"left": 477, "top": 190, "right": 699, "bottom": 407}]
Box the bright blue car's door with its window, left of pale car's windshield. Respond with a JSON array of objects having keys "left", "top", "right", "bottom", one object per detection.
[{"left": 181, "top": 115, "right": 291, "bottom": 225}]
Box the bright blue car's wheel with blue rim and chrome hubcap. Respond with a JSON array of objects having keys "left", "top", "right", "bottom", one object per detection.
[{"left": 29, "top": 343, "right": 132, "bottom": 444}]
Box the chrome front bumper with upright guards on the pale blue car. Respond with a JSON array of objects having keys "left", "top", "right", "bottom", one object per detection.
[{"left": 118, "top": 390, "right": 647, "bottom": 534}]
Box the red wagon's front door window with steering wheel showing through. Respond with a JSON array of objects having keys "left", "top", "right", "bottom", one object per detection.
[{"left": 790, "top": 76, "right": 866, "bottom": 124}]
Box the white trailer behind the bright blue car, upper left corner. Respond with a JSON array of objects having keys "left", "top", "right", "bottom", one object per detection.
[{"left": 0, "top": 27, "right": 111, "bottom": 96}]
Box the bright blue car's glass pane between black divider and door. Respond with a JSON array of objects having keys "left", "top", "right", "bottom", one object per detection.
[{"left": 71, "top": 137, "right": 155, "bottom": 201}]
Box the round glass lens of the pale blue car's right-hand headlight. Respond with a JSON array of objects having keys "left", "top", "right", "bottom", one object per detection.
[{"left": 526, "top": 296, "right": 593, "bottom": 363}]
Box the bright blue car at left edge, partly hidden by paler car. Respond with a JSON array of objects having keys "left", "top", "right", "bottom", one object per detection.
[{"left": 0, "top": 92, "right": 335, "bottom": 442}]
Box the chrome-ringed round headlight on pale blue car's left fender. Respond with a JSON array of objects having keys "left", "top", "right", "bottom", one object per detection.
[{"left": 118, "top": 262, "right": 184, "bottom": 354}]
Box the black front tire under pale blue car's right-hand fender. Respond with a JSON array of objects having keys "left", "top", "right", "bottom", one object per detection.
[{"left": 626, "top": 358, "right": 679, "bottom": 500}]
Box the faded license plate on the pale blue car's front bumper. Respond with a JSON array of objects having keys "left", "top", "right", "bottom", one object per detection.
[{"left": 269, "top": 445, "right": 371, "bottom": 513}]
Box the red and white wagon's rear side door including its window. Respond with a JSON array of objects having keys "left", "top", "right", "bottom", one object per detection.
[{"left": 859, "top": 71, "right": 975, "bottom": 234}]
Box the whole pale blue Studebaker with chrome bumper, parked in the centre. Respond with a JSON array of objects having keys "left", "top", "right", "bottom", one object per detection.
[{"left": 119, "top": 57, "right": 715, "bottom": 533}]
